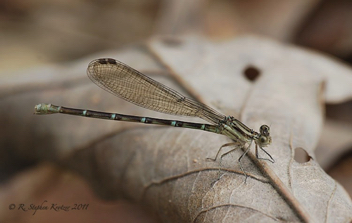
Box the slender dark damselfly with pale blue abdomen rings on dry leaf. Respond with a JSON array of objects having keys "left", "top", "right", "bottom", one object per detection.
[{"left": 35, "top": 58, "right": 275, "bottom": 179}]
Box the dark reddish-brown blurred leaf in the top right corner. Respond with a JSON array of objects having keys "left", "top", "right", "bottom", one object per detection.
[{"left": 296, "top": 0, "right": 352, "bottom": 58}]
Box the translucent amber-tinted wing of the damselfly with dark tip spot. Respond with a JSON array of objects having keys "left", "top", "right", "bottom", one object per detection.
[{"left": 87, "top": 58, "right": 225, "bottom": 124}]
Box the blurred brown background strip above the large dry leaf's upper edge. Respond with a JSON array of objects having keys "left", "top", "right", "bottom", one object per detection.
[{"left": 0, "top": 0, "right": 352, "bottom": 74}]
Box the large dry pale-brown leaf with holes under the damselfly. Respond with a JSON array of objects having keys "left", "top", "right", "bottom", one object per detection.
[{"left": 0, "top": 36, "right": 352, "bottom": 222}]
